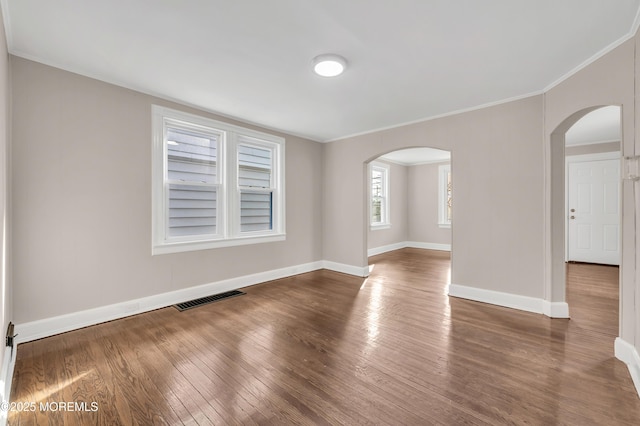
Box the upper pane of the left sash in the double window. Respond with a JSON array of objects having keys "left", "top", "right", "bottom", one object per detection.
[{"left": 167, "top": 128, "right": 217, "bottom": 183}]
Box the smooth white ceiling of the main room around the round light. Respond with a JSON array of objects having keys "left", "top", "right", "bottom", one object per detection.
[{"left": 0, "top": 0, "right": 640, "bottom": 141}]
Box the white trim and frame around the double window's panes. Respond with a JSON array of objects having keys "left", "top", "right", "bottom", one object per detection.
[{"left": 151, "top": 105, "right": 286, "bottom": 255}]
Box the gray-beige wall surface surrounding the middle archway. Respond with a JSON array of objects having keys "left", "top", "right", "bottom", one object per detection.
[{"left": 323, "top": 96, "right": 544, "bottom": 298}]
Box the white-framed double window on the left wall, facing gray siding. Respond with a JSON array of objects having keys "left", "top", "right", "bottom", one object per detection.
[{"left": 152, "top": 106, "right": 285, "bottom": 254}]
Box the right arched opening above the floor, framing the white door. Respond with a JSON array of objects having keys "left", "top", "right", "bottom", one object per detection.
[{"left": 565, "top": 106, "right": 622, "bottom": 265}]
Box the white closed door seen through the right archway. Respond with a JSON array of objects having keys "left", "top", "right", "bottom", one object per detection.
[{"left": 567, "top": 160, "right": 620, "bottom": 265}]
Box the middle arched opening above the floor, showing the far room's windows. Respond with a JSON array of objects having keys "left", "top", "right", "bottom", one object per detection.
[{"left": 364, "top": 147, "right": 453, "bottom": 276}]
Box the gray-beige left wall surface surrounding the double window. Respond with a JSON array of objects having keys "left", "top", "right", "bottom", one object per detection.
[{"left": 11, "top": 57, "right": 322, "bottom": 323}]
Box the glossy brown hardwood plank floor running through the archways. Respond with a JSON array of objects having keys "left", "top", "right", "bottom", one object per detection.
[{"left": 9, "top": 249, "right": 640, "bottom": 425}]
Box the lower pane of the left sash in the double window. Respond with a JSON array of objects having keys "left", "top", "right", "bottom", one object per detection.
[{"left": 169, "top": 185, "right": 218, "bottom": 237}]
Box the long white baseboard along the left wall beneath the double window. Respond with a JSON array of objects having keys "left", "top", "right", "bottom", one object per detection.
[{"left": 15, "top": 261, "right": 322, "bottom": 344}]
